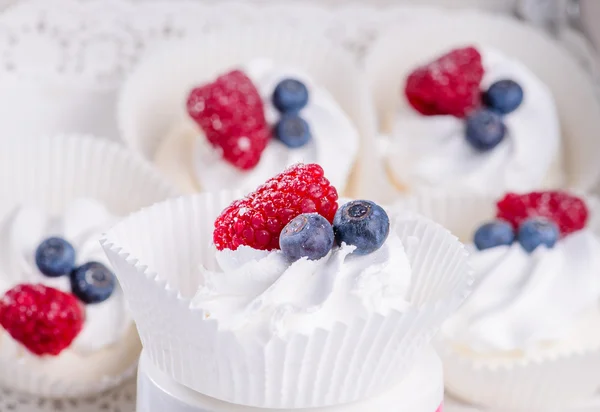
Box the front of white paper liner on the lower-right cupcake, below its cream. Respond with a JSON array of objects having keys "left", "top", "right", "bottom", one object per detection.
[{"left": 439, "top": 343, "right": 600, "bottom": 412}]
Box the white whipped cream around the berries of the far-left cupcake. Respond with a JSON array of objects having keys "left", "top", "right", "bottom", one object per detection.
[{"left": 0, "top": 199, "right": 132, "bottom": 357}]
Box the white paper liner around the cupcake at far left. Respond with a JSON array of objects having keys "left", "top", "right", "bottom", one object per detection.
[{"left": 0, "top": 135, "right": 176, "bottom": 398}]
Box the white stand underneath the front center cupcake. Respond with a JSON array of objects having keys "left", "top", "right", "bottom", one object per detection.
[{"left": 137, "top": 348, "right": 443, "bottom": 412}]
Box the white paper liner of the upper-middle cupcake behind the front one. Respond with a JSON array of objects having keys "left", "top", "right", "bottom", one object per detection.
[{"left": 118, "top": 23, "right": 376, "bottom": 198}]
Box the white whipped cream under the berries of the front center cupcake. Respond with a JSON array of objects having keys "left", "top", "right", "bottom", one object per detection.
[{"left": 193, "top": 230, "right": 411, "bottom": 337}]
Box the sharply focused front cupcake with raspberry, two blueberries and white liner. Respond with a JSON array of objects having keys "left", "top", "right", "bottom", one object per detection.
[{"left": 103, "top": 164, "right": 470, "bottom": 408}]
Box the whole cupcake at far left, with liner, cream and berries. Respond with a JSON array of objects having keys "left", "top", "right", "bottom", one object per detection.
[{"left": 0, "top": 136, "right": 175, "bottom": 398}]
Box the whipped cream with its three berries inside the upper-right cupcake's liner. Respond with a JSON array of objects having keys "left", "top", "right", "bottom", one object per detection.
[{"left": 382, "top": 46, "right": 562, "bottom": 193}]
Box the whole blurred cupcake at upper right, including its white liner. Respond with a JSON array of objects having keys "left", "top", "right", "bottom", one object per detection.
[{"left": 367, "top": 12, "right": 600, "bottom": 205}]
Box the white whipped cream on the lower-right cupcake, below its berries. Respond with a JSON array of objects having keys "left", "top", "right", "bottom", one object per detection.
[{"left": 443, "top": 229, "right": 600, "bottom": 353}]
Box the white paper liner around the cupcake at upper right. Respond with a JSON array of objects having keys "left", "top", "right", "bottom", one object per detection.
[{"left": 365, "top": 11, "right": 600, "bottom": 201}]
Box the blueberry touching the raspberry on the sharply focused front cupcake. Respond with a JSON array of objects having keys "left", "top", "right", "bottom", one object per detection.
[{"left": 279, "top": 213, "right": 333, "bottom": 260}]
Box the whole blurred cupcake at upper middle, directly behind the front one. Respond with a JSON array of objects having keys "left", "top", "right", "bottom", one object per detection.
[{"left": 119, "top": 29, "right": 374, "bottom": 193}]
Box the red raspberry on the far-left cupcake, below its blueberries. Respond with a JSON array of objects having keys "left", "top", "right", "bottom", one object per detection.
[{"left": 0, "top": 284, "right": 85, "bottom": 356}]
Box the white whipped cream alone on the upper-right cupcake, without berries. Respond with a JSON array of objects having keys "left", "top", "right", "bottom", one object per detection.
[{"left": 383, "top": 48, "right": 560, "bottom": 192}]
